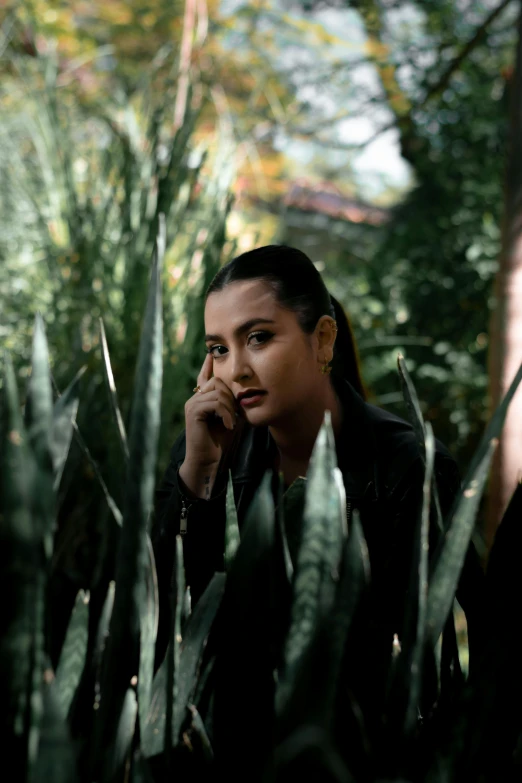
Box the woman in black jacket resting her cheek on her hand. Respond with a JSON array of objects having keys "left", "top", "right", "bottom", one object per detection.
[{"left": 153, "top": 245, "right": 483, "bottom": 672}]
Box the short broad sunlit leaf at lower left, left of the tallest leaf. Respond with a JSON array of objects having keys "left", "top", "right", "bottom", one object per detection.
[{"left": 53, "top": 590, "right": 89, "bottom": 717}]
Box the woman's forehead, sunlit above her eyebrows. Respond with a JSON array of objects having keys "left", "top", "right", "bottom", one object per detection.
[{"left": 205, "top": 280, "right": 282, "bottom": 330}]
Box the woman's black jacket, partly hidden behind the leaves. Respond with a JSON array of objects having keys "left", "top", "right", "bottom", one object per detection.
[{"left": 152, "top": 381, "right": 484, "bottom": 664}]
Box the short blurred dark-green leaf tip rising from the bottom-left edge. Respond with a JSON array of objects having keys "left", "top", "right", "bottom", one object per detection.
[{"left": 29, "top": 668, "right": 79, "bottom": 783}]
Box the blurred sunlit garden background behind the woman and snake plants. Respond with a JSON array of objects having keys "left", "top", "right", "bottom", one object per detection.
[{"left": 0, "top": 0, "right": 522, "bottom": 612}]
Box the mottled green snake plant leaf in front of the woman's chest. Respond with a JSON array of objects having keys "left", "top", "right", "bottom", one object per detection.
[{"left": 277, "top": 411, "right": 344, "bottom": 714}]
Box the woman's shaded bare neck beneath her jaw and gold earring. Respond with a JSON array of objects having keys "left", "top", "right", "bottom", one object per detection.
[{"left": 269, "top": 380, "right": 343, "bottom": 465}]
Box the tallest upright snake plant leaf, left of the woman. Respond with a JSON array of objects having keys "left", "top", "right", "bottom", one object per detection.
[{"left": 91, "top": 223, "right": 164, "bottom": 776}]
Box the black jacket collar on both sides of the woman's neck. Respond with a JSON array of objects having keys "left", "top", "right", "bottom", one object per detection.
[{"left": 231, "top": 379, "right": 379, "bottom": 499}]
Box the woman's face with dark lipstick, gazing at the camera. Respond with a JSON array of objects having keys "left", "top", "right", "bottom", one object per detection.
[{"left": 205, "top": 280, "right": 330, "bottom": 425}]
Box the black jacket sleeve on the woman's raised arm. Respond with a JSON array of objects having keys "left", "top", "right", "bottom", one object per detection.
[{"left": 151, "top": 430, "right": 227, "bottom": 663}]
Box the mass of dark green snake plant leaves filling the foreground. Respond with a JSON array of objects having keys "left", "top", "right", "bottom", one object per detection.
[{"left": 0, "top": 253, "right": 522, "bottom": 783}]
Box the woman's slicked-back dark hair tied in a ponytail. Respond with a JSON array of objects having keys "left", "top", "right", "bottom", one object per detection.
[{"left": 205, "top": 245, "right": 368, "bottom": 400}]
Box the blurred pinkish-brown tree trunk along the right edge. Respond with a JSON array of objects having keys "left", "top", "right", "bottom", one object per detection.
[{"left": 484, "top": 3, "right": 522, "bottom": 548}]
